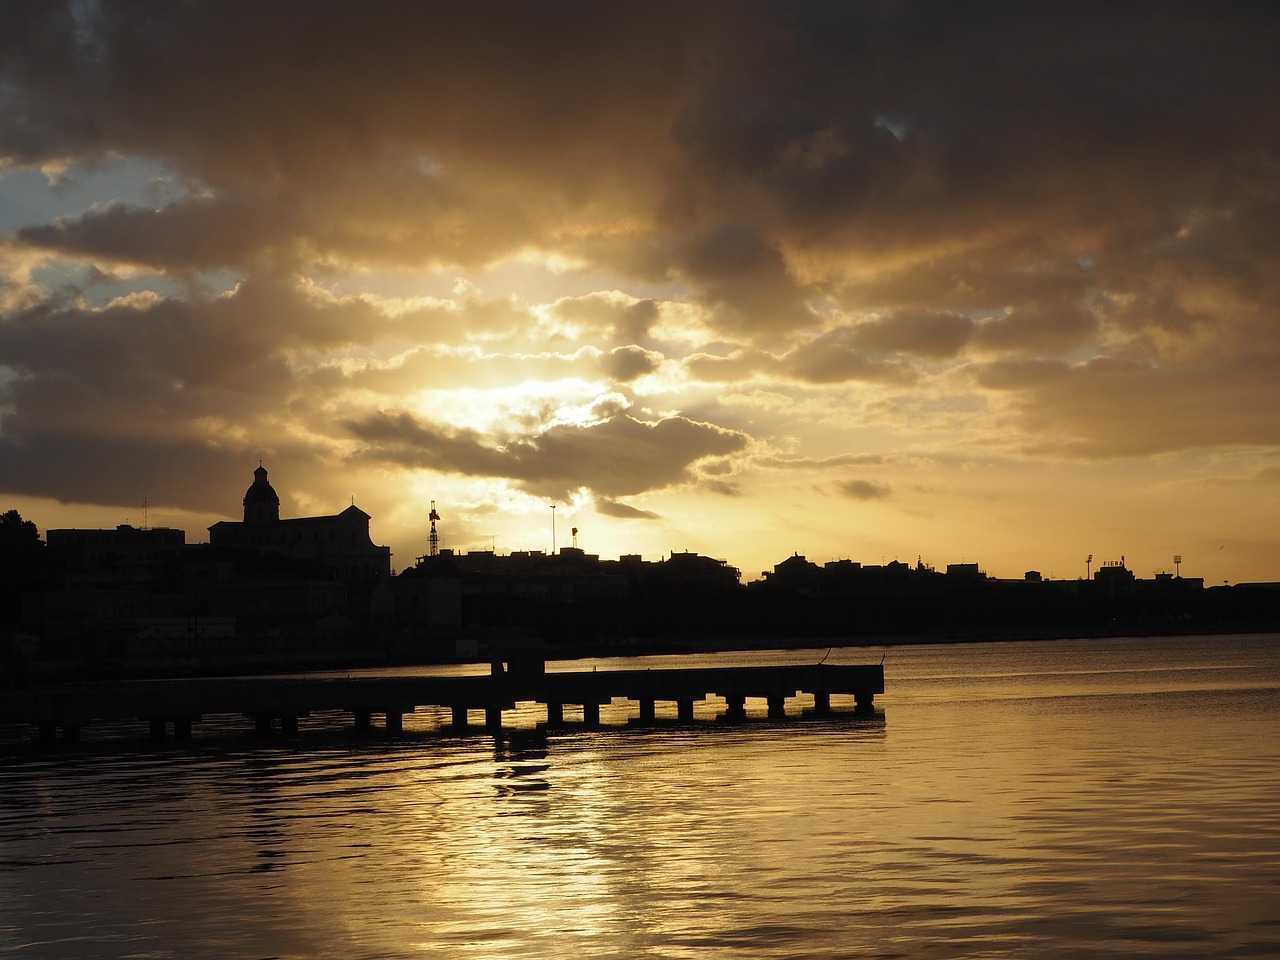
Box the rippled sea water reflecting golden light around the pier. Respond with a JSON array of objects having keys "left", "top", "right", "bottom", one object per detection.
[{"left": 0, "top": 635, "right": 1280, "bottom": 960}]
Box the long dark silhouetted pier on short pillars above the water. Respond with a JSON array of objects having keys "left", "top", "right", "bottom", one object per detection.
[{"left": 0, "top": 659, "right": 884, "bottom": 744}]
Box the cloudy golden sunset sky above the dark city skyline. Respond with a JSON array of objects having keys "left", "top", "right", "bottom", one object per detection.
[{"left": 0, "top": 0, "right": 1280, "bottom": 584}]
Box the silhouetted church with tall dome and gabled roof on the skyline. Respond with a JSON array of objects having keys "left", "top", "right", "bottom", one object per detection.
[{"left": 209, "top": 465, "right": 392, "bottom": 582}]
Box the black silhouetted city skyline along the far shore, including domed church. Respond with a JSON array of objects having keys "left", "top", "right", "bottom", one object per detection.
[{"left": 0, "top": 481, "right": 1280, "bottom": 686}]
